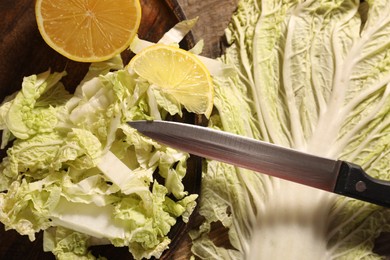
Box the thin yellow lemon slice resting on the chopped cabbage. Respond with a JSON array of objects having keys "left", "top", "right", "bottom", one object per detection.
[{"left": 129, "top": 44, "right": 214, "bottom": 117}]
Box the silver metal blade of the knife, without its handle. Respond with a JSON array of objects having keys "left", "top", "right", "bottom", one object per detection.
[{"left": 129, "top": 121, "right": 341, "bottom": 192}]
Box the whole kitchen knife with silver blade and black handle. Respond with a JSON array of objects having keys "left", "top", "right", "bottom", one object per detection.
[{"left": 128, "top": 120, "right": 390, "bottom": 207}]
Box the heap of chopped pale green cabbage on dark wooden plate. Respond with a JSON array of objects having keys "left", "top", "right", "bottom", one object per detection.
[{"left": 0, "top": 33, "right": 198, "bottom": 259}]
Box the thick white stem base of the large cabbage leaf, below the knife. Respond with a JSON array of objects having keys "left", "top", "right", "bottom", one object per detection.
[{"left": 245, "top": 180, "right": 334, "bottom": 260}]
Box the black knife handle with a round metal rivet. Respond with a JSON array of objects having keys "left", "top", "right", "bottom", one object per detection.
[{"left": 334, "top": 161, "right": 390, "bottom": 207}]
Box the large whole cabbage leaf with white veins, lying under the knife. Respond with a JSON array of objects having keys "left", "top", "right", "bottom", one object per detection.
[{"left": 191, "top": 0, "right": 390, "bottom": 259}]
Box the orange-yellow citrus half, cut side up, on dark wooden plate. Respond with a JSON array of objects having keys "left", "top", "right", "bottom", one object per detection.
[{"left": 35, "top": 0, "right": 141, "bottom": 62}]
